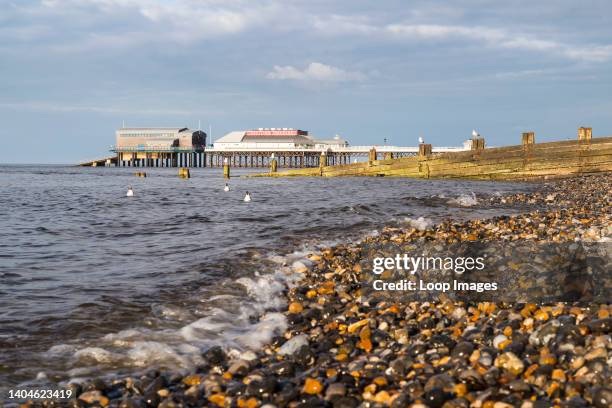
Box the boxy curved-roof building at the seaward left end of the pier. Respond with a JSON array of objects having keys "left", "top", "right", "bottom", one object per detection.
[{"left": 111, "top": 128, "right": 206, "bottom": 167}]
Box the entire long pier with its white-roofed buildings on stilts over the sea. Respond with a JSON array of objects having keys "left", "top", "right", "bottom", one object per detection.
[{"left": 93, "top": 128, "right": 470, "bottom": 168}]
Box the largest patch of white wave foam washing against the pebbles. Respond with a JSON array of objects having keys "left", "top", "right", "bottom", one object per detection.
[{"left": 48, "top": 243, "right": 320, "bottom": 386}]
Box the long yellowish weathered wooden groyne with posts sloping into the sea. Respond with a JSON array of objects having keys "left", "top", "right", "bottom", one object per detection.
[{"left": 251, "top": 128, "right": 612, "bottom": 180}]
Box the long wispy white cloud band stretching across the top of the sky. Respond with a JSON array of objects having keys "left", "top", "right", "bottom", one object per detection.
[{"left": 8, "top": 0, "right": 612, "bottom": 62}]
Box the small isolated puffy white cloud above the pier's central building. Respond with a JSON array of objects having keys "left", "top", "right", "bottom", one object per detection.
[{"left": 267, "top": 62, "right": 366, "bottom": 82}]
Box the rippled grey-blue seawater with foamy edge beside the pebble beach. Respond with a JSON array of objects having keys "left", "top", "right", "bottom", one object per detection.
[{"left": 0, "top": 166, "right": 534, "bottom": 388}]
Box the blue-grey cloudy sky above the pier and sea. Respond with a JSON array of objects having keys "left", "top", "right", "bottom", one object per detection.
[{"left": 0, "top": 0, "right": 612, "bottom": 163}]
